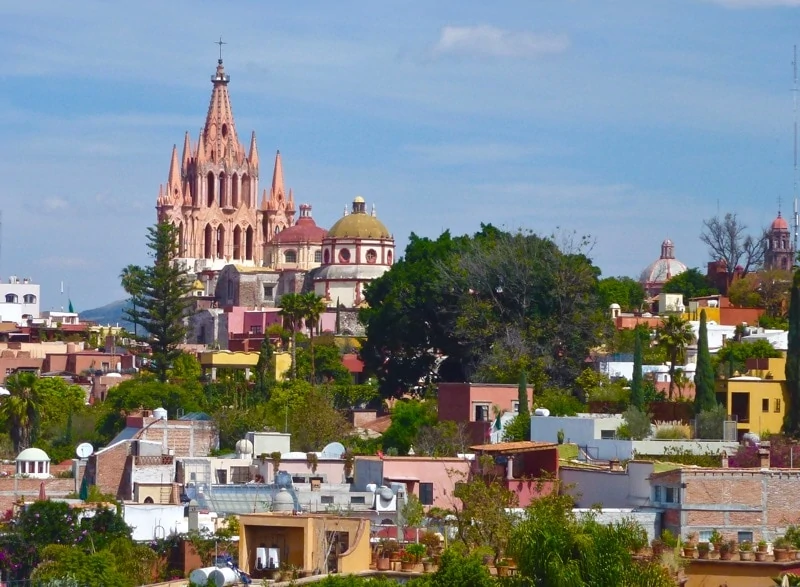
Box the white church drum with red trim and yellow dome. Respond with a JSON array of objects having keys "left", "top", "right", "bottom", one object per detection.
[{"left": 314, "top": 196, "right": 394, "bottom": 308}]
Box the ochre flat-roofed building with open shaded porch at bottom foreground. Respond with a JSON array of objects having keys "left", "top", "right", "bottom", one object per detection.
[{"left": 239, "top": 504, "right": 372, "bottom": 579}]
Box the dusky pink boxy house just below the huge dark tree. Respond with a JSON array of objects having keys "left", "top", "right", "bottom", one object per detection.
[{"left": 439, "top": 383, "right": 533, "bottom": 443}]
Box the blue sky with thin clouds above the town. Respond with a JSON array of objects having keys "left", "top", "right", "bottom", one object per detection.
[{"left": 0, "top": 0, "right": 800, "bottom": 310}]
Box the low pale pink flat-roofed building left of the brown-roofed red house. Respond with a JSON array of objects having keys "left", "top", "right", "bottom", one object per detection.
[{"left": 353, "top": 456, "right": 471, "bottom": 509}]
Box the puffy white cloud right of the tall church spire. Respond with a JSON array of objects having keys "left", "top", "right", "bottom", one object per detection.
[{"left": 434, "top": 25, "right": 569, "bottom": 58}]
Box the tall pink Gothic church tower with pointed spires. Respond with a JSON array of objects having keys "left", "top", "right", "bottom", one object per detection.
[{"left": 156, "top": 54, "right": 295, "bottom": 272}]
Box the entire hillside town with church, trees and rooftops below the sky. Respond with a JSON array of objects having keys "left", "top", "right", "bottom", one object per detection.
[{"left": 0, "top": 20, "right": 800, "bottom": 587}]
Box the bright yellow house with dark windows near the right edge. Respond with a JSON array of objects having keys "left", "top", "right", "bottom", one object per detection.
[{"left": 723, "top": 357, "right": 788, "bottom": 437}]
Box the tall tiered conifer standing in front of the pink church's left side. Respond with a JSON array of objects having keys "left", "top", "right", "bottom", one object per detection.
[{"left": 122, "top": 222, "right": 191, "bottom": 382}]
